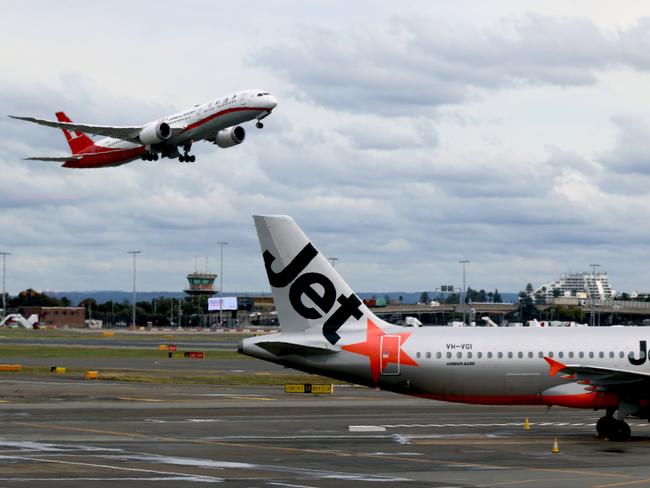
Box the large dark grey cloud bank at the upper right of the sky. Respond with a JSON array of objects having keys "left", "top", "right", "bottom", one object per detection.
[{"left": 253, "top": 14, "right": 650, "bottom": 115}]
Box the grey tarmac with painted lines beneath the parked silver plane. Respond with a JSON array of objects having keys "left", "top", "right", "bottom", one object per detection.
[{"left": 0, "top": 370, "right": 650, "bottom": 488}]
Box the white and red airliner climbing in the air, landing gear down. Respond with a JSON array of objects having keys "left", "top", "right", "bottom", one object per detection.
[{"left": 9, "top": 90, "right": 278, "bottom": 168}]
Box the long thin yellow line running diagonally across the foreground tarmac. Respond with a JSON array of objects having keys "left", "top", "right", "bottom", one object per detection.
[{"left": 13, "top": 421, "right": 632, "bottom": 482}]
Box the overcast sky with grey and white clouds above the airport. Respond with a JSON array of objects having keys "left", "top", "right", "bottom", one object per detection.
[{"left": 0, "top": 0, "right": 650, "bottom": 293}]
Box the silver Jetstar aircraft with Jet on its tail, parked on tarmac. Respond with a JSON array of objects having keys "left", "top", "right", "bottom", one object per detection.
[{"left": 239, "top": 216, "right": 650, "bottom": 440}]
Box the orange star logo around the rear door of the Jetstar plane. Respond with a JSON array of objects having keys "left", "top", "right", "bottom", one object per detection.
[{"left": 341, "top": 319, "right": 419, "bottom": 383}]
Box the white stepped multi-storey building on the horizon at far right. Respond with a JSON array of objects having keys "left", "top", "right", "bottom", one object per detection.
[{"left": 535, "top": 272, "right": 615, "bottom": 301}]
